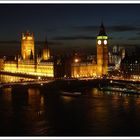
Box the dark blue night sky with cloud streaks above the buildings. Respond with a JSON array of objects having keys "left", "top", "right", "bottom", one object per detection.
[{"left": 0, "top": 4, "right": 140, "bottom": 55}]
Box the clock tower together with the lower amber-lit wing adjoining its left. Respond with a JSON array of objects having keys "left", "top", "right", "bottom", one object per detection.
[{"left": 71, "top": 24, "right": 108, "bottom": 77}]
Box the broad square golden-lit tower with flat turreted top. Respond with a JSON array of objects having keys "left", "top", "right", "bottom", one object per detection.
[{"left": 21, "top": 32, "right": 34, "bottom": 60}]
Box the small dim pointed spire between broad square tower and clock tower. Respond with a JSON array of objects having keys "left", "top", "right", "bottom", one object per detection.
[{"left": 42, "top": 39, "right": 50, "bottom": 60}]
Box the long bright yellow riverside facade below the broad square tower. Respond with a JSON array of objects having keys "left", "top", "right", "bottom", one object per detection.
[{"left": 4, "top": 61, "right": 54, "bottom": 77}]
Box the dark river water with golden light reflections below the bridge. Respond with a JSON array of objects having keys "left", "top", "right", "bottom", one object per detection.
[{"left": 0, "top": 76, "right": 140, "bottom": 136}]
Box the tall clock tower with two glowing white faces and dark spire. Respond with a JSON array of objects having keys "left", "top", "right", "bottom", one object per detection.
[{"left": 96, "top": 23, "right": 108, "bottom": 76}]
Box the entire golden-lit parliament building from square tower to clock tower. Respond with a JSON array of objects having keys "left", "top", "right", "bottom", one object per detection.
[{"left": 1, "top": 23, "right": 108, "bottom": 78}]
